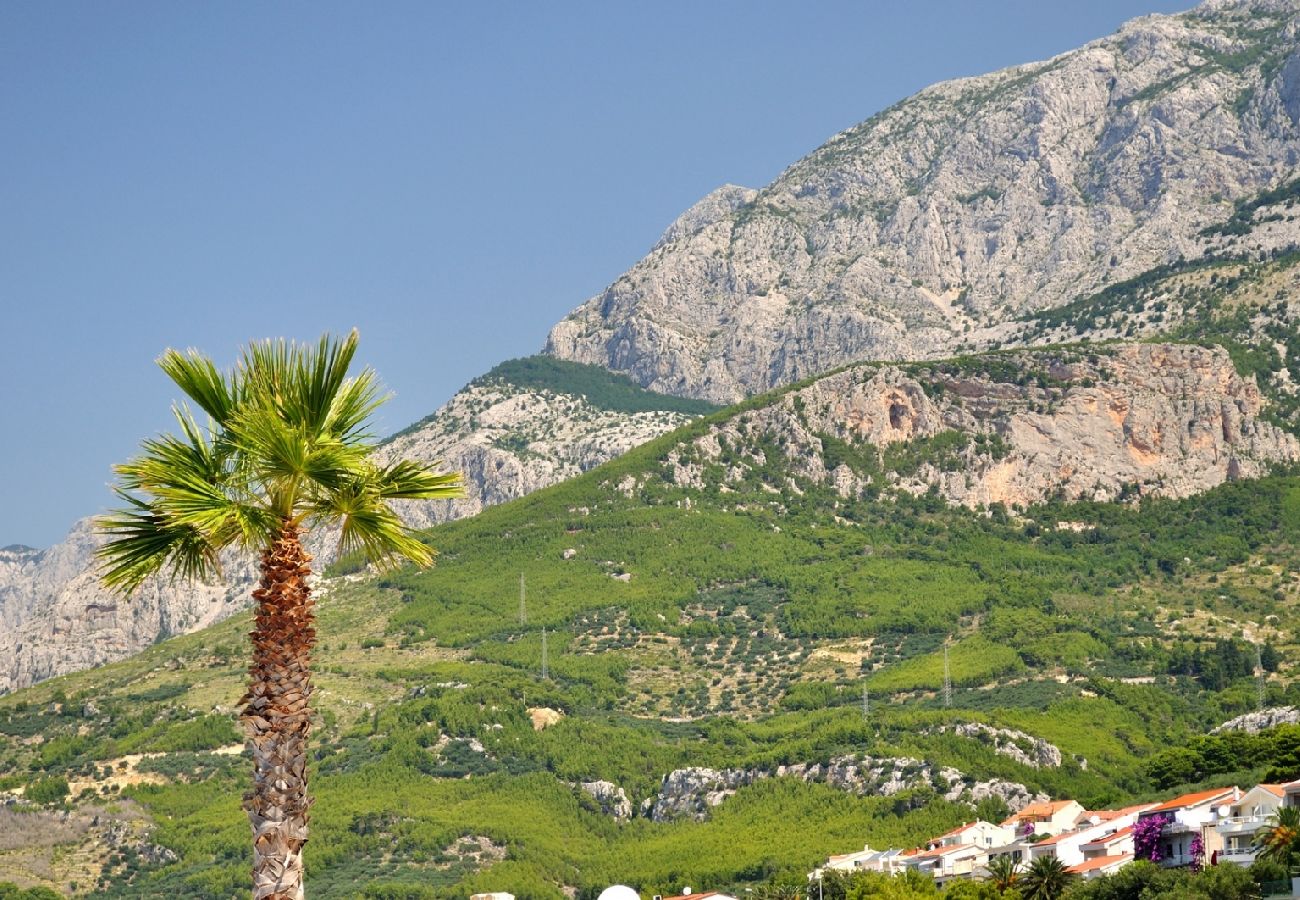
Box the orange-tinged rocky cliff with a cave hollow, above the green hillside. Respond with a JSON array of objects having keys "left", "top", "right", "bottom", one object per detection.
[{"left": 668, "top": 343, "right": 1300, "bottom": 507}]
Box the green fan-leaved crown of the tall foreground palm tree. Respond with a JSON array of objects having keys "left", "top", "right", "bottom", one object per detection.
[{"left": 99, "top": 332, "right": 458, "bottom": 592}]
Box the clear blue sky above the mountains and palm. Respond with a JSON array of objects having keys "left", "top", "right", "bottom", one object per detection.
[{"left": 0, "top": 0, "right": 1191, "bottom": 546}]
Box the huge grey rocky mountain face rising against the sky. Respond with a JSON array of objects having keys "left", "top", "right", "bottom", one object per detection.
[{"left": 546, "top": 0, "right": 1300, "bottom": 402}]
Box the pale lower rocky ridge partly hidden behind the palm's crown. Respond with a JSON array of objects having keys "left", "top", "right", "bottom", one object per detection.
[{"left": 0, "top": 381, "right": 689, "bottom": 693}]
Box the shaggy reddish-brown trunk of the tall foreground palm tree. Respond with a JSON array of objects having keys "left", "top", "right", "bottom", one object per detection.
[{"left": 239, "top": 522, "right": 316, "bottom": 900}]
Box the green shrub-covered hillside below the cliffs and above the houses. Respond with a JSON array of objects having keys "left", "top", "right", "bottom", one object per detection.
[{"left": 0, "top": 340, "right": 1300, "bottom": 897}]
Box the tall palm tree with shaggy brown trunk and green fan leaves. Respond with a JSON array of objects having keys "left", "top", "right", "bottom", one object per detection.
[{"left": 98, "top": 330, "right": 459, "bottom": 900}]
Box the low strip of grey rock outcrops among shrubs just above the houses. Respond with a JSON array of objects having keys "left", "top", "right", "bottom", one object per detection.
[{"left": 641, "top": 754, "right": 1049, "bottom": 822}]
